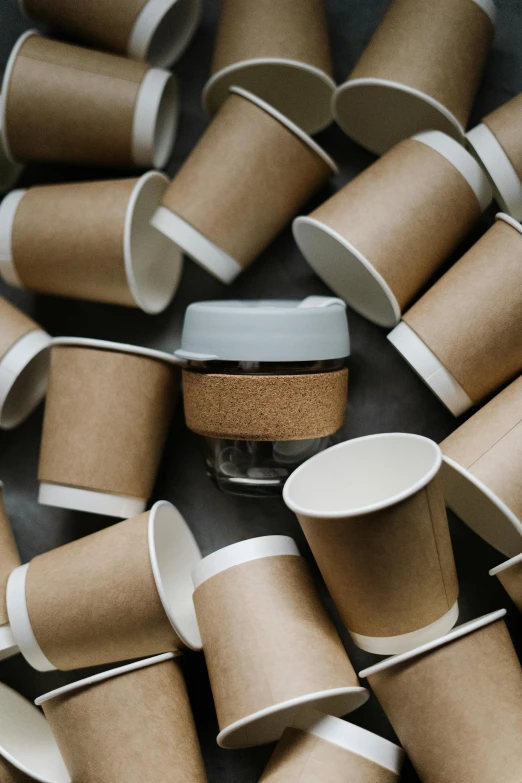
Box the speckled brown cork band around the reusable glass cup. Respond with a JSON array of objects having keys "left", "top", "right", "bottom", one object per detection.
[{"left": 183, "top": 369, "right": 348, "bottom": 440}]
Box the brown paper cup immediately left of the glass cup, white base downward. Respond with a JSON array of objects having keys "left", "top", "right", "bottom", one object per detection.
[{"left": 38, "top": 337, "right": 180, "bottom": 517}]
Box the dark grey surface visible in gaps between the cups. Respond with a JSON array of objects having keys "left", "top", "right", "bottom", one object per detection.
[{"left": 0, "top": 0, "right": 522, "bottom": 783}]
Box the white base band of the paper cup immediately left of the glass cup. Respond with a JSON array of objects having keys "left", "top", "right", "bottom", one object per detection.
[{"left": 38, "top": 482, "right": 147, "bottom": 519}]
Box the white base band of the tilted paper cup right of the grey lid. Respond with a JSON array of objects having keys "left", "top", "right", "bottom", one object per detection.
[{"left": 388, "top": 321, "right": 473, "bottom": 416}]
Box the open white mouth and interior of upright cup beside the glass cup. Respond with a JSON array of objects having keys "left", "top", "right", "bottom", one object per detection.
[{"left": 284, "top": 433, "right": 441, "bottom": 517}]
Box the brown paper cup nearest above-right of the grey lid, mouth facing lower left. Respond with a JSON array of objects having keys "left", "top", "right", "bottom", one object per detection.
[{"left": 293, "top": 132, "right": 492, "bottom": 327}]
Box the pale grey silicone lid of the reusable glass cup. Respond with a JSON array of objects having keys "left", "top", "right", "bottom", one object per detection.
[{"left": 176, "top": 296, "right": 350, "bottom": 362}]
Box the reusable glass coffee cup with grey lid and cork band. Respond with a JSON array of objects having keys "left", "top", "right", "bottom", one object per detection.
[{"left": 176, "top": 296, "right": 350, "bottom": 495}]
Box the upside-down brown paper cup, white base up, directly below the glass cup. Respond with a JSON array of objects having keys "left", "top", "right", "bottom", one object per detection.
[{"left": 193, "top": 536, "right": 368, "bottom": 748}]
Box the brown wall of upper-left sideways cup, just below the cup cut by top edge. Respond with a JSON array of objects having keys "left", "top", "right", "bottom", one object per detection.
[{"left": 5, "top": 35, "right": 149, "bottom": 165}]
